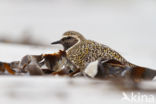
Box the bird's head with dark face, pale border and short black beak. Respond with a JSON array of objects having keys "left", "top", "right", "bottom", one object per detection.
[{"left": 51, "top": 31, "right": 85, "bottom": 51}]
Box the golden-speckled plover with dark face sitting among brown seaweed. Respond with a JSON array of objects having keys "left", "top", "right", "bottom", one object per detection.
[{"left": 51, "top": 31, "right": 136, "bottom": 72}]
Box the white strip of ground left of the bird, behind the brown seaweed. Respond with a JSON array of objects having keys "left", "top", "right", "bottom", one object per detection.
[{"left": 0, "top": 43, "right": 63, "bottom": 62}]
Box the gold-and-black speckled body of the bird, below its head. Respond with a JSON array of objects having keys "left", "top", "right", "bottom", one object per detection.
[{"left": 67, "top": 40, "right": 135, "bottom": 70}]
